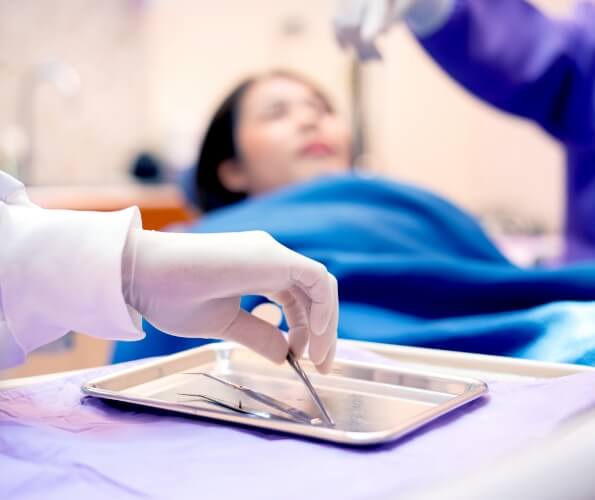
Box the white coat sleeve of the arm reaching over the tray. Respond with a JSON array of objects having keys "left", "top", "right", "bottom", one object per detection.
[{"left": 0, "top": 172, "right": 144, "bottom": 368}]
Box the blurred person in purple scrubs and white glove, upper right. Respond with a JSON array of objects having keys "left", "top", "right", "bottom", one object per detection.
[{"left": 335, "top": 0, "right": 595, "bottom": 261}]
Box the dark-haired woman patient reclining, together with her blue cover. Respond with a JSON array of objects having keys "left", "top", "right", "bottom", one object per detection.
[{"left": 116, "top": 72, "right": 595, "bottom": 364}]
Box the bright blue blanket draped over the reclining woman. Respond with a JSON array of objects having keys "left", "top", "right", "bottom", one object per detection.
[{"left": 115, "top": 175, "right": 595, "bottom": 364}]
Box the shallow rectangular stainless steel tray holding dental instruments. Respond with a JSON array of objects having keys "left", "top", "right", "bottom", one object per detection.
[{"left": 82, "top": 343, "right": 487, "bottom": 445}]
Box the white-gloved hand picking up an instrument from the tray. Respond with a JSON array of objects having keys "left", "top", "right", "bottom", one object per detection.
[{"left": 122, "top": 230, "right": 338, "bottom": 373}]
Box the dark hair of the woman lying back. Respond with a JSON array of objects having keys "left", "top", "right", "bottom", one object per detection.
[{"left": 193, "top": 71, "right": 332, "bottom": 212}]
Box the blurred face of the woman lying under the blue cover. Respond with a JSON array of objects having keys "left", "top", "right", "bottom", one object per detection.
[{"left": 226, "top": 76, "right": 350, "bottom": 195}]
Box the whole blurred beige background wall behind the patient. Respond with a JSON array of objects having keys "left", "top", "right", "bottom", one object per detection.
[{"left": 0, "top": 0, "right": 571, "bottom": 229}]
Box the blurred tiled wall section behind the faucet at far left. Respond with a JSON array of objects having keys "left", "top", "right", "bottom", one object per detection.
[{"left": 0, "top": 0, "right": 147, "bottom": 184}]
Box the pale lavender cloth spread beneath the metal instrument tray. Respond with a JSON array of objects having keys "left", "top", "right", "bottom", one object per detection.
[{"left": 0, "top": 354, "right": 595, "bottom": 500}]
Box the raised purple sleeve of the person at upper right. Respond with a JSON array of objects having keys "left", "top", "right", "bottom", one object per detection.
[{"left": 421, "top": 0, "right": 595, "bottom": 144}]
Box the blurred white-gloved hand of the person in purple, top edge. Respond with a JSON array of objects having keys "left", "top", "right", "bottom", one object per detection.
[{"left": 333, "top": 0, "right": 454, "bottom": 60}]
